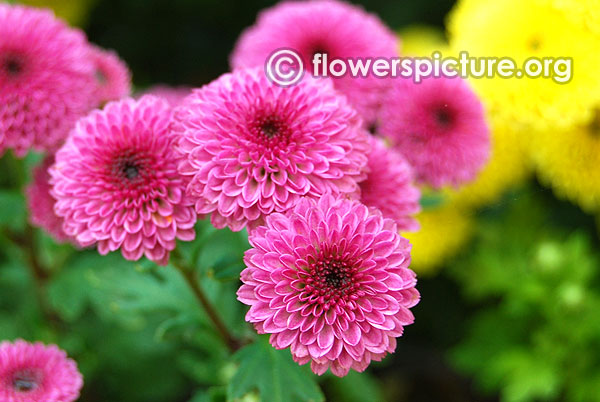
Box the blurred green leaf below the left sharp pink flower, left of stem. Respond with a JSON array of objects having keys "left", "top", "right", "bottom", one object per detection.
[{"left": 49, "top": 251, "right": 202, "bottom": 328}]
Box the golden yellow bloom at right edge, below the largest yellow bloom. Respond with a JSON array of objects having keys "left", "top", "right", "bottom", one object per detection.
[{"left": 530, "top": 108, "right": 600, "bottom": 212}]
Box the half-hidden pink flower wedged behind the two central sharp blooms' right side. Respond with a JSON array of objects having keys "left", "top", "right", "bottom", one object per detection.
[{"left": 360, "top": 138, "right": 421, "bottom": 231}]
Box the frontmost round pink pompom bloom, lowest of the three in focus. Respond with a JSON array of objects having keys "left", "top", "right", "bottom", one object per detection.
[{"left": 237, "top": 196, "right": 419, "bottom": 376}]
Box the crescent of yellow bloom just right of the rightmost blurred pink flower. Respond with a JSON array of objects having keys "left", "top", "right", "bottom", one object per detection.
[{"left": 449, "top": 112, "right": 530, "bottom": 208}]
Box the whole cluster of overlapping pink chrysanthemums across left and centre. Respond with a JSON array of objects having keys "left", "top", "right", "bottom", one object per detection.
[{"left": 0, "top": 0, "right": 489, "bottom": 380}]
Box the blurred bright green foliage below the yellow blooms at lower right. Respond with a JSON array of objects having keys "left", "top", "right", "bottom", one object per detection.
[{"left": 451, "top": 192, "right": 600, "bottom": 402}]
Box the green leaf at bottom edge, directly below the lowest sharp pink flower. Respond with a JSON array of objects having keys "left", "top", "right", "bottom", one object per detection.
[{"left": 227, "top": 336, "right": 324, "bottom": 402}]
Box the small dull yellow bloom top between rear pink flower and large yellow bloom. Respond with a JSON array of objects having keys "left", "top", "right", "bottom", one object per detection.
[{"left": 399, "top": 25, "right": 449, "bottom": 57}]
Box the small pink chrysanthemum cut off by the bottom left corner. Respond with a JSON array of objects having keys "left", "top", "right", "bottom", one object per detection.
[{"left": 0, "top": 340, "right": 83, "bottom": 402}]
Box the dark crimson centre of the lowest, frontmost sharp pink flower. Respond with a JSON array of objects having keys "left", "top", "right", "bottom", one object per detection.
[{"left": 304, "top": 251, "right": 359, "bottom": 310}]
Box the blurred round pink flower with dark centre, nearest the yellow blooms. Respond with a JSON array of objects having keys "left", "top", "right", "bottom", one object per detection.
[{"left": 380, "top": 77, "right": 490, "bottom": 188}]
